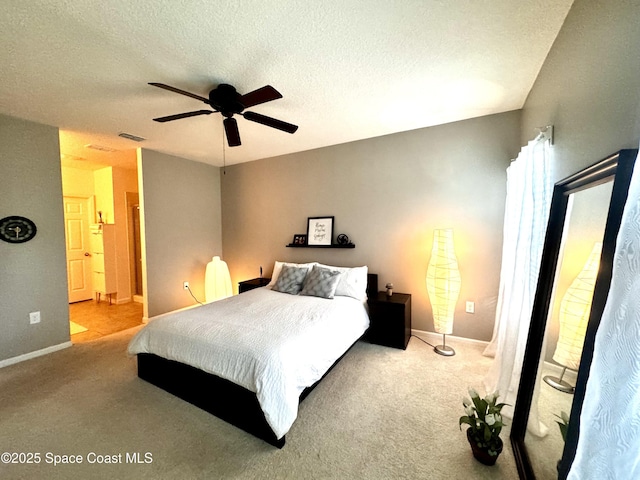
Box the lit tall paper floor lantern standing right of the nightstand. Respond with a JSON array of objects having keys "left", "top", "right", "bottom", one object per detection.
[{"left": 427, "top": 228, "right": 460, "bottom": 356}]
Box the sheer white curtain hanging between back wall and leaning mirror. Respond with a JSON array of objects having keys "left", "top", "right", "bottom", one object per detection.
[{"left": 484, "top": 140, "right": 553, "bottom": 435}]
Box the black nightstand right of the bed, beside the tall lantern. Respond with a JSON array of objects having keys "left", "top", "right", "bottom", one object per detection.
[{"left": 366, "top": 292, "right": 411, "bottom": 350}]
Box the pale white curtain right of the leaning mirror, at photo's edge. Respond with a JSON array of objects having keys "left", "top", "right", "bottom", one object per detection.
[{"left": 568, "top": 149, "right": 640, "bottom": 480}]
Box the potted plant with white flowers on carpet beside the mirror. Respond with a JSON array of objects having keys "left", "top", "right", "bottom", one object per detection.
[{"left": 459, "top": 388, "right": 507, "bottom": 465}]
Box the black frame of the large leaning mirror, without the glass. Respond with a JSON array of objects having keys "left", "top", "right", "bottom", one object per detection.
[{"left": 510, "top": 149, "right": 638, "bottom": 480}]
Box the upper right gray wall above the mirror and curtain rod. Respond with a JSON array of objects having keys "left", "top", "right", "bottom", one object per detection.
[{"left": 521, "top": 0, "right": 640, "bottom": 180}]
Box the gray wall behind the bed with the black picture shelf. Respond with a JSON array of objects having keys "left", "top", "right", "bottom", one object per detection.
[{"left": 222, "top": 112, "right": 520, "bottom": 340}]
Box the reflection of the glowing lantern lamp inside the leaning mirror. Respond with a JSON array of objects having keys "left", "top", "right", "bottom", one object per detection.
[{"left": 543, "top": 242, "right": 602, "bottom": 393}]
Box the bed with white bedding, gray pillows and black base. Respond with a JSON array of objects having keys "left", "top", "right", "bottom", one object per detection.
[{"left": 129, "top": 262, "right": 377, "bottom": 448}]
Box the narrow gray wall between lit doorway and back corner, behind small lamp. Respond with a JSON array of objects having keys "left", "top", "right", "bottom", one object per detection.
[{"left": 139, "top": 149, "right": 222, "bottom": 317}]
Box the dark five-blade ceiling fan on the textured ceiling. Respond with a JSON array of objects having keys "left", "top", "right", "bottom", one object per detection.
[{"left": 149, "top": 83, "right": 298, "bottom": 147}]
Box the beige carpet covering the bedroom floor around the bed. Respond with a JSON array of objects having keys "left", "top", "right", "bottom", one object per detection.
[{"left": 0, "top": 329, "right": 517, "bottom": 480}]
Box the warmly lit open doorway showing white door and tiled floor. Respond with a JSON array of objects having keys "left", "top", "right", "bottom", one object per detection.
[{"left": 60, "top": 139, "right": 144, "bottom": 343}]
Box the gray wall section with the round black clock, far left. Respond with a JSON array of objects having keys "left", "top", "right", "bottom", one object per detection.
[{"left": 0, "top": 115, "right": 69, "bottom": 360}]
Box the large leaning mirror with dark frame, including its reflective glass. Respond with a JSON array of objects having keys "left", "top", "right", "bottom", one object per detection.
[{"left": 511, "top": 150, "right": 638, "bottom": 480}]
